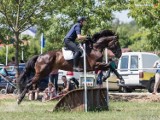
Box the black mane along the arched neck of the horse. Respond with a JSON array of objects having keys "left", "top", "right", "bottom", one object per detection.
[{"left": 92, "top": 30, "right": 116, "bottom": 42}]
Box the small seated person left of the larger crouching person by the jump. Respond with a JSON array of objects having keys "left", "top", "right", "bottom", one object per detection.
[{"left": 42, "top": 82, "right": 56, "bottom": 101}]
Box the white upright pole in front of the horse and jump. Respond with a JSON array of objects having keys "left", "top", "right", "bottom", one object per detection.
[{"left": 83, "top": 44, "right": 87, "bottom": 112}]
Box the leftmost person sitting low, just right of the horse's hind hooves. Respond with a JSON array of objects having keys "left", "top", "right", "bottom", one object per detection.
[{"left": 28, "top": 84, "right": 39, "bottom": 100}]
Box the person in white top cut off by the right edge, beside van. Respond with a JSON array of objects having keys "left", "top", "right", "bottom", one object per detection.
[{"left": 152, "top": 59, "right": 160, "bottom": 94}]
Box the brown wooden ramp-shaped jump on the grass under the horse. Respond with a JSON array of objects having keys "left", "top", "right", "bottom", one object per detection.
[{"left": 54, "top": 88, "right": 108, "bottom": 111}]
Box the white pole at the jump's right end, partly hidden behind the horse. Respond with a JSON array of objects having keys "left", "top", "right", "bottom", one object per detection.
[{"left": 105, "top": 48, "right": 109, "bottom": 107}]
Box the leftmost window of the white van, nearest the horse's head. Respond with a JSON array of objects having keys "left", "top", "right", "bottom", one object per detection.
[{"left": 120, "top": 56, "right": 128, "bottom": 71}]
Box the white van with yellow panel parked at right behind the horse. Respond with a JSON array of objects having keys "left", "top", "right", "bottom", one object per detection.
[{"left": 118, "top": 52, "right": 159, "bottom": 92}]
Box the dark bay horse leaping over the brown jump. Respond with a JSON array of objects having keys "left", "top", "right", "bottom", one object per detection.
[{"left": 17, "top": 30, "right": 122, "bottom": 104}]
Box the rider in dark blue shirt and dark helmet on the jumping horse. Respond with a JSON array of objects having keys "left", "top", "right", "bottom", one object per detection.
[{"left": 64, "top": 16, "right": 88, "bottom": 72}]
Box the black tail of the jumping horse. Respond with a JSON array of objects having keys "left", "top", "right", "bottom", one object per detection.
[{"left": 17, "top": 55, "right": 39, "bottom": 93}]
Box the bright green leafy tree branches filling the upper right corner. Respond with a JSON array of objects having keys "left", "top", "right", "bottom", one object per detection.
[{"left": 128, "top": 0, "right": 160, "bottom": 50}]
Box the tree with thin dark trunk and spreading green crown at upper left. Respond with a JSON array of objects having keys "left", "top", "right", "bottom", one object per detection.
[{"left": 0, "top": 0, "right": 55, "bottom": 72}]
